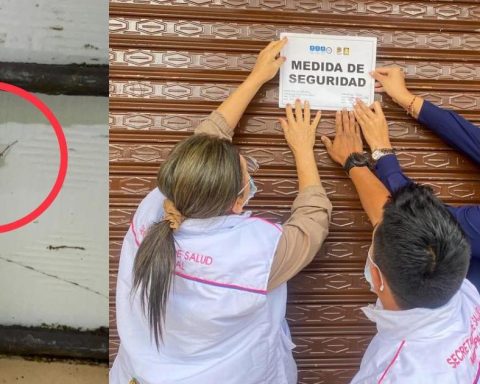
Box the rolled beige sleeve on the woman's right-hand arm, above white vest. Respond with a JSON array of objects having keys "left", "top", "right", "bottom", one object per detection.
[{"left": 268, "top": 185, "right": 332, "bottom": 290}]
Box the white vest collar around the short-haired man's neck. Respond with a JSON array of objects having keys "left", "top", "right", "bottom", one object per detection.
[{"left": 362, "top": 282, "right": 465, "bottom": 340}]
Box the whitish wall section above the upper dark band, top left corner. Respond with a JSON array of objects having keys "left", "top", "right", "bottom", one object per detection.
[{"left": 0, "top": 0, "right": 108, "bottom": 64}]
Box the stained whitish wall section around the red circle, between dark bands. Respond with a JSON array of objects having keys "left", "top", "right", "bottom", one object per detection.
[{"left": 0, "top": 94, "right": 108, "bottom": 328}]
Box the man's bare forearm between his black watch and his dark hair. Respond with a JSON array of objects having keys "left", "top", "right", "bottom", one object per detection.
[{"left": 349, "top": 167, "right": 390, "bottom": 226}]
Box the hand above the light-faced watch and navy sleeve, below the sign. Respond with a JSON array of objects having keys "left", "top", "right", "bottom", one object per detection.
[{"left": 353, "top": 99, "right": 392, "bottom": 152}]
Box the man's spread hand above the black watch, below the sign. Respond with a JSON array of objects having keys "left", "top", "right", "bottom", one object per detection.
[{"left": 321, "top": 110, "right": 363, "bottom": 167}]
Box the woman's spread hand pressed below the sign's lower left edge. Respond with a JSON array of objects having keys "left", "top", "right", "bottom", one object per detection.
[{"left": 280, "top": 100, "right": 322, "bottom": 156}]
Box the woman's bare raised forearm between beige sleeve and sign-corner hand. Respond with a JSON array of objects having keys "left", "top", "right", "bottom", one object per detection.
[{"left": 217, "top": 75, "right": 263, "bottom": 128}]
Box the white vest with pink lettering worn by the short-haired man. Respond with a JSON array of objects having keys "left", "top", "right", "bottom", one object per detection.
[{"left": 352, "top": 280, "right": 480, "bottom": 384}]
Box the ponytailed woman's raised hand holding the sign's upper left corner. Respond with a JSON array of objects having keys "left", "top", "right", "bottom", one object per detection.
[{"left": 249, "top": 37, "right": 287, "bottom": 85}]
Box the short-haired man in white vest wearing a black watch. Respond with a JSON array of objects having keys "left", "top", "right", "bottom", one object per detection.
[{"left": 322, "top": 105, "right": 480, "bottom": 384}]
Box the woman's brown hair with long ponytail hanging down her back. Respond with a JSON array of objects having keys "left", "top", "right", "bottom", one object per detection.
[{"left": 132, "top": 134, "right": 243, "bottom": 347}]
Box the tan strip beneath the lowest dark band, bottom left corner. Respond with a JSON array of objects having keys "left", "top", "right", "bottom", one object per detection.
[{"left": 0, "top": 356, "right": 108, "bottom": 384}]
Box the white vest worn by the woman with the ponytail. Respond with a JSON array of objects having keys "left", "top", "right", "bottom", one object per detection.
[{"left": 110, "top": 189, "right": 296, "bottom": 384}]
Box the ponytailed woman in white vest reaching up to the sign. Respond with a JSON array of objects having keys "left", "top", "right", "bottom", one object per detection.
[{"left": 110, "top": 36, "right": 332, "bottom": 384}]
